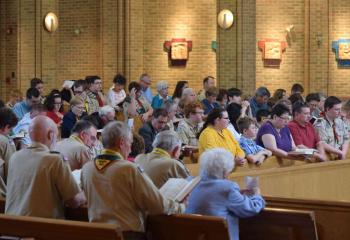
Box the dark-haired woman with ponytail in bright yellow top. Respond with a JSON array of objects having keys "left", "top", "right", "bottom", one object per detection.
[{"left": 198, "top": 108, "right": 247, "bottom": 165}]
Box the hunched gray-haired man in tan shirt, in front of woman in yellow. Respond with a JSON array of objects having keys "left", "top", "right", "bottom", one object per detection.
[{"left": 135, "top": 130, "right": 189, "bottom": 188}]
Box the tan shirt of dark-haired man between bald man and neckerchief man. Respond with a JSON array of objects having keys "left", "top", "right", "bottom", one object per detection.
[{"left": 55, "top": 135, "right": 93, "bottom": 171}]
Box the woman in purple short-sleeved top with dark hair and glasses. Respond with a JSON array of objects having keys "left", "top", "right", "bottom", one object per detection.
[{"left": 256, "top": 104, "right": 297, "bottom": 158}]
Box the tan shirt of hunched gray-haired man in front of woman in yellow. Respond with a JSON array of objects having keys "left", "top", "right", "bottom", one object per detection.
[{"left": 135, "top": 148, "right": 189, "bottom": 188}]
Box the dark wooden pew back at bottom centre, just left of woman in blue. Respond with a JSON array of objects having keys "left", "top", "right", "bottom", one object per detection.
[{"left": 147, "top": 214, "right": 230, "bottom": 240}]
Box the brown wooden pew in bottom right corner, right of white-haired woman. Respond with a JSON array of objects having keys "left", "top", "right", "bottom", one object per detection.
[{"left": 264, "top": 197, "right": 350, "bottom": 240}]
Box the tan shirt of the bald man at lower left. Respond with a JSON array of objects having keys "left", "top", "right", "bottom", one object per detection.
[{"left": 5, "top": 142, "right": 81, "bottom": 218}]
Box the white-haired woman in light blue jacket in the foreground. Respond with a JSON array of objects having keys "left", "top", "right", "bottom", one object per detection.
[{"left": 186, "top": 148, "right": 265, "bottom": 240}]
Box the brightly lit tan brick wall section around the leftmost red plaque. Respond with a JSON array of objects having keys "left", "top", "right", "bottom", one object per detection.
[{"left": 143, "top": 0, "right": 216, "bottom": 93}]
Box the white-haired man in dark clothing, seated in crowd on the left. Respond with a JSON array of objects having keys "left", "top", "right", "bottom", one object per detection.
[{"left": 83, "top": 105, "right": 115, "bottom": 129}]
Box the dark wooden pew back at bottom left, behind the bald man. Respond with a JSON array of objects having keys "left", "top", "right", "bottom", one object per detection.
[{"left": 0, "top": 214, "right": 122, "bottom": 240}]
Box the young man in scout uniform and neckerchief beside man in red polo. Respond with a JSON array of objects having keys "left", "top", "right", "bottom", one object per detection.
[{"left": 314, "top": 96, "right": 349, "bottom": 159}]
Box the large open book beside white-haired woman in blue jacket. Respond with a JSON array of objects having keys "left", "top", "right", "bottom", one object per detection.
[{"left": 159, "top": 176, "right": 201, "bottom": 202}]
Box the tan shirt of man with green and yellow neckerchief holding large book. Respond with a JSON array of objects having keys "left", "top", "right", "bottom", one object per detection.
[{"left": 82, "top": 150, "right": 184, "bottom": 232}]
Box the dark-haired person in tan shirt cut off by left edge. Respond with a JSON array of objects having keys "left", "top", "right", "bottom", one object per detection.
[{"left": 0, "top": 108, "right": 18, "bottom": 182}]
